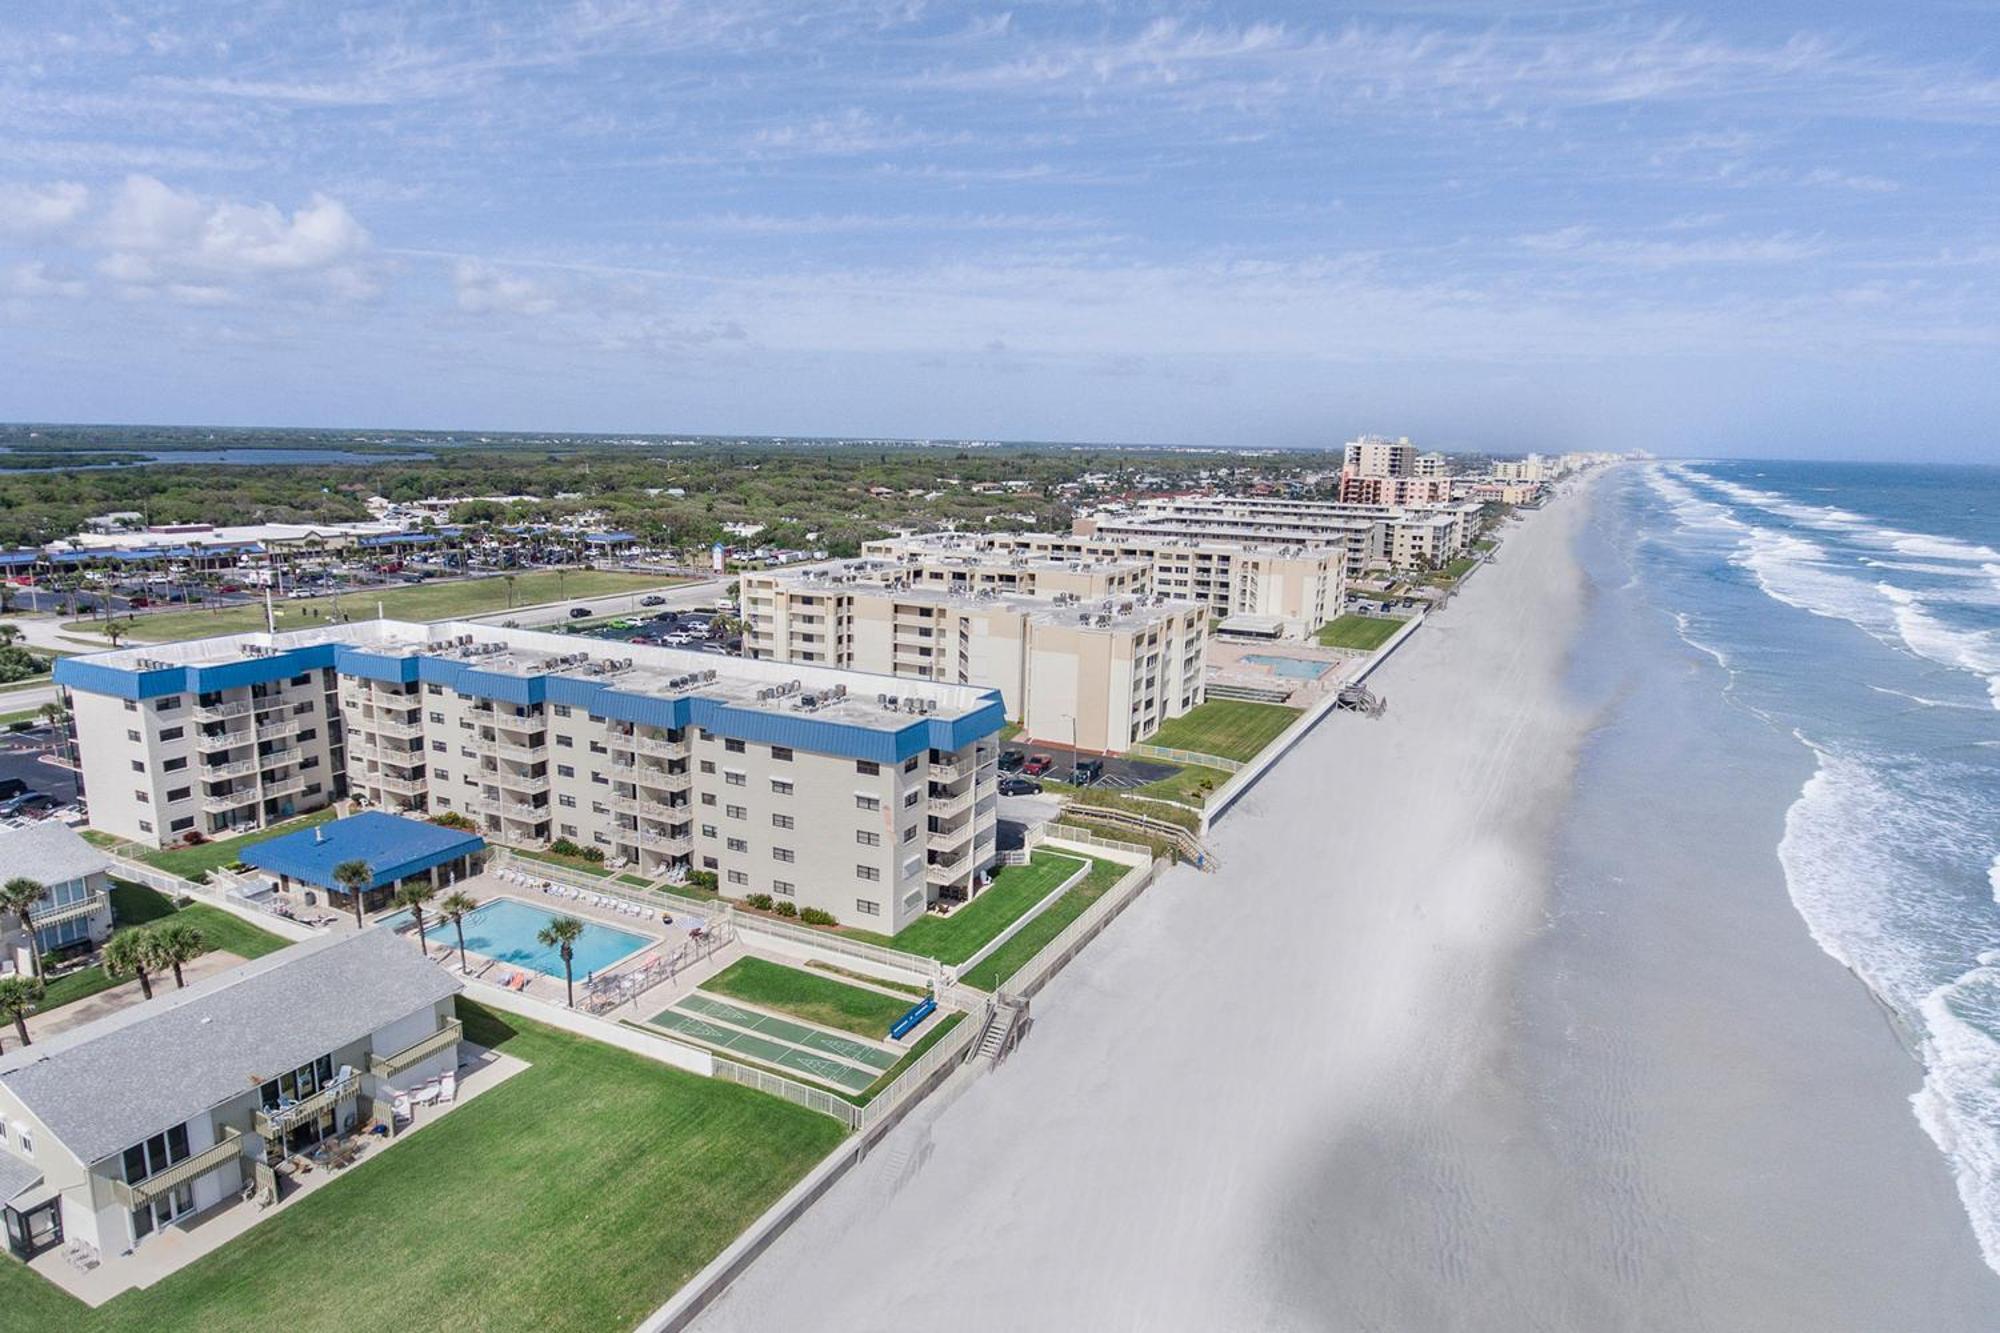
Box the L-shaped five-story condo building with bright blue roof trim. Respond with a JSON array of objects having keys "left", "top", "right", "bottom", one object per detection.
[{"left": 56, "top": 620, "right": 1006, "bottom": 933}]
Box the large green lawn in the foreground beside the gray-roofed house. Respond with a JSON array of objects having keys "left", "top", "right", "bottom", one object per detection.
[{"left": 0, "top": 1001, "right": 846, "bottom": 1333}]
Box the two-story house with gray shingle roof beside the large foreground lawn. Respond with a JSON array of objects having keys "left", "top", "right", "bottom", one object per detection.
[{"left": 0, "top": 931, "right": 462, "bottom": 1259}]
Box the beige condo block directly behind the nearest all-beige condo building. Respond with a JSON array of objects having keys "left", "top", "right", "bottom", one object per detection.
[{"left": 862, "top": 518, "right": 1366, "bottom": 638}]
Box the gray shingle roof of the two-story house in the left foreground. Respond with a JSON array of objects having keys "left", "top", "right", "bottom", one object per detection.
[{"left": 0, "top": 929, "right": 460, "bottom": 1163}]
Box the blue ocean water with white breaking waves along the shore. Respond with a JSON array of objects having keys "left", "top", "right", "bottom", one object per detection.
[{"left": 1604, "top": 462, "right": 2000, "bottom": 1271}]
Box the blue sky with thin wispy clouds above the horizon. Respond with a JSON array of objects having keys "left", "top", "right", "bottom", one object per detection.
[{"left": 0, "top": 0, "right": 2000, "bottom": 460}]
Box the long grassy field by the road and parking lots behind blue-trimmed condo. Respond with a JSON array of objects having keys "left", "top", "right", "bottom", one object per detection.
[{"left": 78, "top": 568, "right": 684, "bottom": 642}]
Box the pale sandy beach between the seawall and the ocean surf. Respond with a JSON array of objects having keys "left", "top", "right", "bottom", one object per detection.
[{"left": 700, "top": 472, "right": 2000, "bottom": 1331}]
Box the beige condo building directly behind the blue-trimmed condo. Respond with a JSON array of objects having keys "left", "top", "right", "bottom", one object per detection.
[{"left": 742, "top": 550, "right": 1208, "bottom": 753}]
